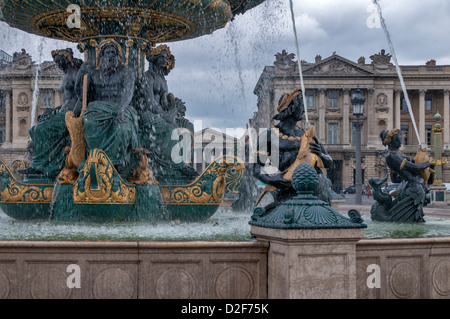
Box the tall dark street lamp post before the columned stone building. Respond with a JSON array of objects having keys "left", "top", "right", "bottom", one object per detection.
[{"left": 352, "top": 89, "right": 366, "bottom": 205}]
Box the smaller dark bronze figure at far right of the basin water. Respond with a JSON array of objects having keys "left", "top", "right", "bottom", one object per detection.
[{"left": 369, "top": 129, "right": 430, "bottom": 223}]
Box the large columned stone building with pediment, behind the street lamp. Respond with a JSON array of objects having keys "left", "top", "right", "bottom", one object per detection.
[{"left": 251, "top": 50, "right": 450, "bottom": 191}]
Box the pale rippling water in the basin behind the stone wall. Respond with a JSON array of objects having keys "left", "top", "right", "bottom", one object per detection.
[{"left": 0, "top": 210, "right": 450, "bottom": 241}]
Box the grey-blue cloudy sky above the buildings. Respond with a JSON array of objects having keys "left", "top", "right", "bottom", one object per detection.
[{"left": 0, "top": 0, "right": 450, "bottom": 136}]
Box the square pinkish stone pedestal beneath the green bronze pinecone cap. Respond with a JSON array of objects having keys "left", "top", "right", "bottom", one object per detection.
[{"left": 251, "top": 226, "right": 364, "bottom": 299}]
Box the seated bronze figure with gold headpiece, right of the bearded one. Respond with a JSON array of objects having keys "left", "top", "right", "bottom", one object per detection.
[{"left": 138, "top": 45, "right": 198, "bottom": 183}]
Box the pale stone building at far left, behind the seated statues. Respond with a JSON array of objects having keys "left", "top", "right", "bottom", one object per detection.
[{"left": 0, "top": 50, "right": 64, "bottom": 165}]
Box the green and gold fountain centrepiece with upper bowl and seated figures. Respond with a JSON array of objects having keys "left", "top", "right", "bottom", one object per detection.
[{"left": 0, "top": 0, "right": 263, "bottom": 222}]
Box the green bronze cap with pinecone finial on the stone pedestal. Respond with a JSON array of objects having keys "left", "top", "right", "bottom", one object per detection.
[{"left": 249, "top": 163, "right": 367, "bottom": 229}]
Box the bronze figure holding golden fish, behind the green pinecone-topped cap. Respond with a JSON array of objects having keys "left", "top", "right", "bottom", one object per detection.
[{"left": 253, "top": 89, "right": 333, "bottom": 212}]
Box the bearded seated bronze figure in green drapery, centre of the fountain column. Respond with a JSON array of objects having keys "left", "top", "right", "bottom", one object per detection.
[{"left": 76, "top": 39, "right": 139, "bottom": 174}]
